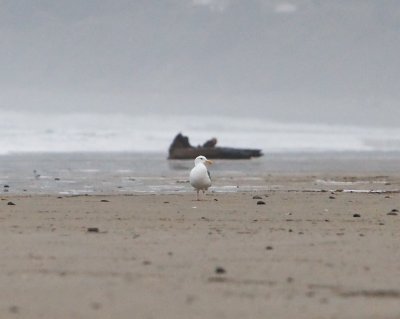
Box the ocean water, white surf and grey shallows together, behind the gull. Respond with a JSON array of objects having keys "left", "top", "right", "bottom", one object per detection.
[{"left": 0, "top": 112, "right": 400, "bottom": 194}]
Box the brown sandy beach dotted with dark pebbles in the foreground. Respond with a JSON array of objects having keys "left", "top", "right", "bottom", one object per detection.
[{"left": 0, "top": 178, "right": 400, "bottom": 319}]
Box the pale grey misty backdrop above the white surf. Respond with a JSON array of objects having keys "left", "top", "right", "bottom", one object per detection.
[{"left": 0, "top": 0, "right": 400, "bottom": 125}]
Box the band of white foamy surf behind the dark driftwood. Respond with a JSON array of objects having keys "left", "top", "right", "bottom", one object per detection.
[{"left": 0, "top": 112, "right": 400, "bottom": 154}]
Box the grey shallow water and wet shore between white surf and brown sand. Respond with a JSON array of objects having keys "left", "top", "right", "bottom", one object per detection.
[{"left": 0, "top": 153, "right": 400, "bottom": 195}]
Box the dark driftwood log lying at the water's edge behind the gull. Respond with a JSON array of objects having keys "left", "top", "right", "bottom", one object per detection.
[{"left": 168, "top": 133, "right": 263, "bottom": 159}]
